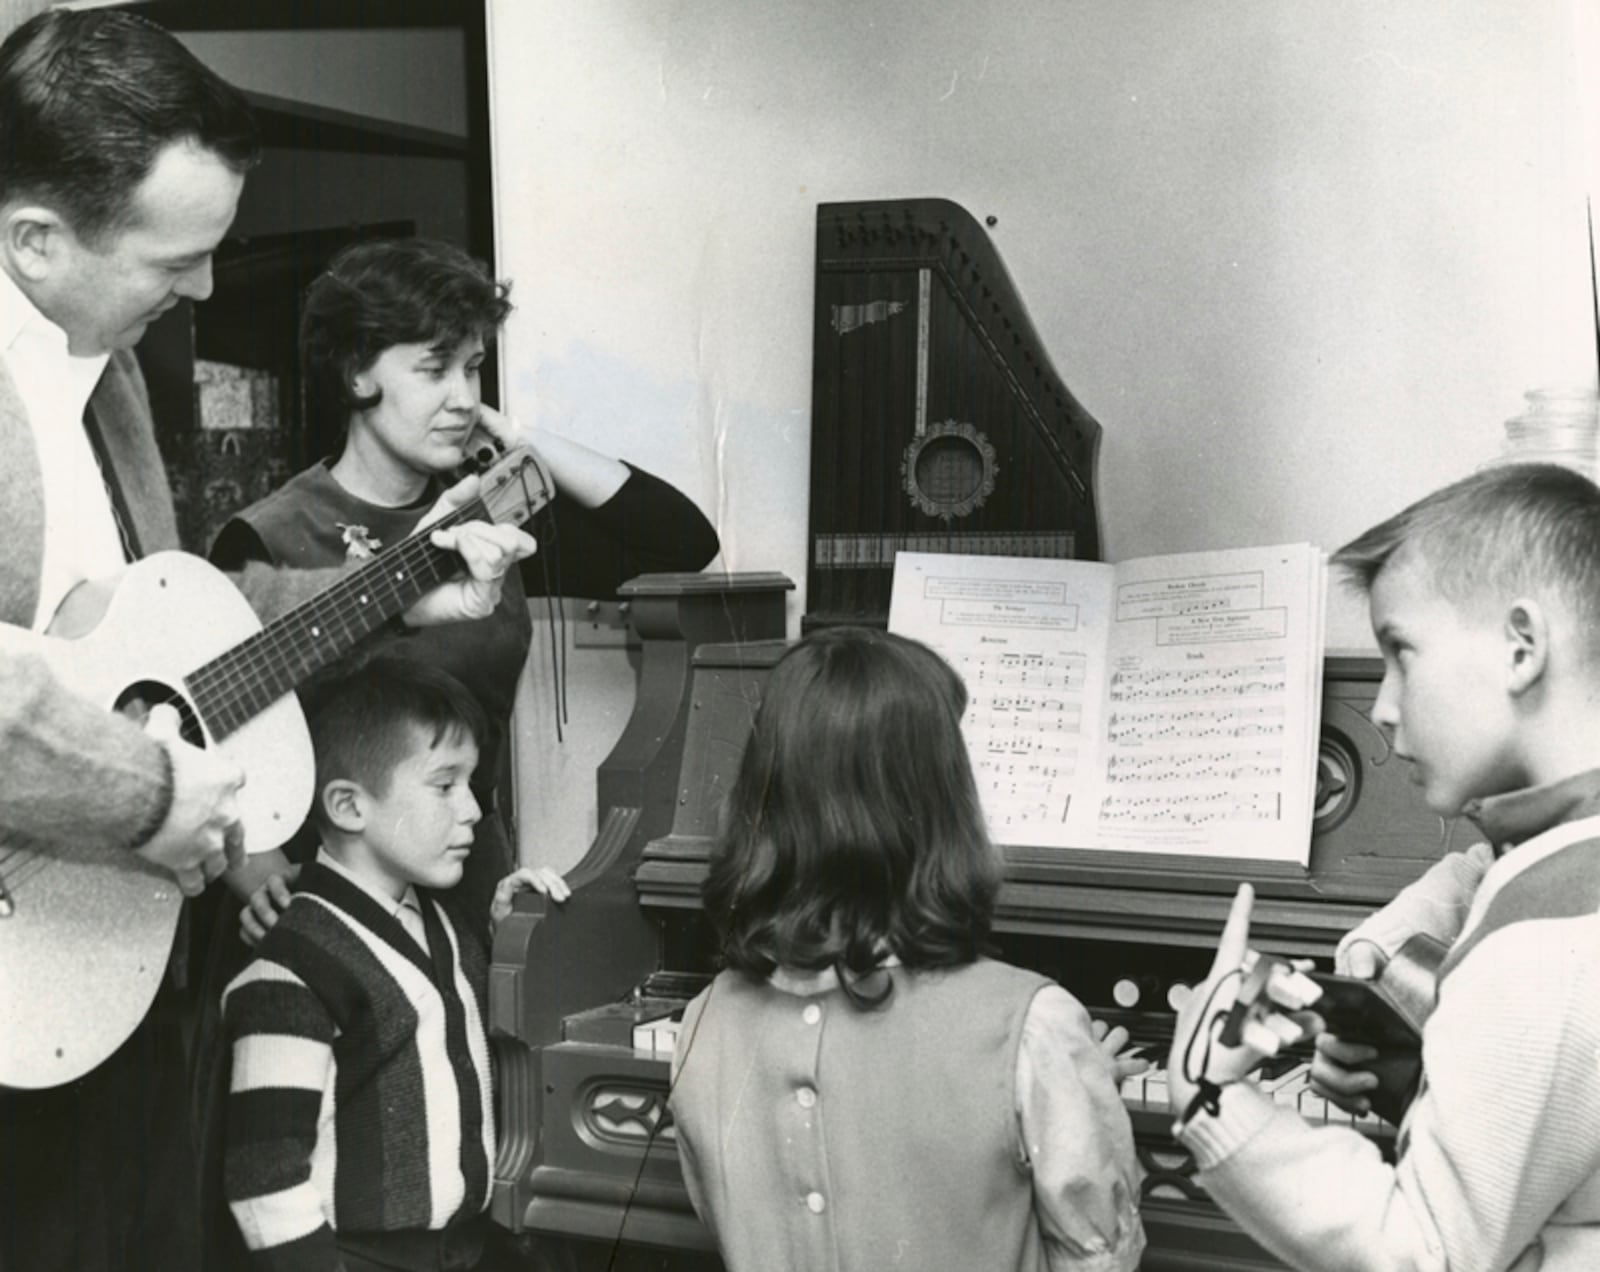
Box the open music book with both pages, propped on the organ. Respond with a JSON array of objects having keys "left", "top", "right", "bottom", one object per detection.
[{"left": 890, "top": 544, "right": 1326, "bottom": 866}]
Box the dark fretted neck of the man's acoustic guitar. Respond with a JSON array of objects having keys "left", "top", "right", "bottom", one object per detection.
[{"left": 184, "top": 499, "right": 490, "bottom": 739}]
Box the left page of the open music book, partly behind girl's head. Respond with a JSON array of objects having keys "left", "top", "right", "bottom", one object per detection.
[{"left": 890, "top": 552, "right": 1115, "bottom": 846}]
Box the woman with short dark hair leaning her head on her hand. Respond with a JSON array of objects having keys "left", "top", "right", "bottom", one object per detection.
[{"left": 211, "top": 238, "right": 718, "bottom": 931}]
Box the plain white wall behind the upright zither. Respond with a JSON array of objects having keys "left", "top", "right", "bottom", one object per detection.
[{"left": 490, "top": 0, "right": 1595, "bottom": 662}]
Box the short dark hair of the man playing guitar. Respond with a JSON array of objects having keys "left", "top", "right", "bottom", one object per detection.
[{"left": 0, "top": 10, "right": 261, "bottom": 243}]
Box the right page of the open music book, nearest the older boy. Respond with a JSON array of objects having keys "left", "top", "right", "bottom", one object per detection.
[{"left": 1098, "top": 544, "right": 1326, "bottom": 866}]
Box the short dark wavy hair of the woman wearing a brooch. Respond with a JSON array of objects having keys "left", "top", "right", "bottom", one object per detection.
[{"left": 292, "top": 238, "right": 510, "bottom": 434}]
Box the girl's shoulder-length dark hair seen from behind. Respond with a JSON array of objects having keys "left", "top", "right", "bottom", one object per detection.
[{"left": 704, "top": 627, "right": 1000, "bottom": 1003}]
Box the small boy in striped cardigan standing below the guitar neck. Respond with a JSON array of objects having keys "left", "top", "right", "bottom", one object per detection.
[{"left": 222, "top": 656, "right": 568, "bottom": 1272}]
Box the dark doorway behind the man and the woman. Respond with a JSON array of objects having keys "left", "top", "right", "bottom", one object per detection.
[{"left": 122, "top": 0, "right": 498, "bottom": 552}]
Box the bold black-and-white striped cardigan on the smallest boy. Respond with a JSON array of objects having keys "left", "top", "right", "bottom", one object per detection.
[{"left": 222, "top": 864, "right": 494, "bottom": 1272}]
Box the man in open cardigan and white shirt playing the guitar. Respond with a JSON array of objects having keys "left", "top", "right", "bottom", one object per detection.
[{"left": 0, "top": 11, "right": 533, "bottom": 1272}]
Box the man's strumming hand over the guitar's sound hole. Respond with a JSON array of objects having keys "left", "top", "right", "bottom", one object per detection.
[{"left": 139, "top": 704, "right": 245, "bottom": 896}]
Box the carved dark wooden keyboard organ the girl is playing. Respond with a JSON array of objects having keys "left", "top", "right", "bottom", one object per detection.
[{"left": 490, "top": 640, "right": 1464, "bottom": 1272}]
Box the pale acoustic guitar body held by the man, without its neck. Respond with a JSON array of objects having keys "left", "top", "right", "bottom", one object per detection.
[{"left": 0, "top": 552, "right": 315, "bottom": 1088}]
